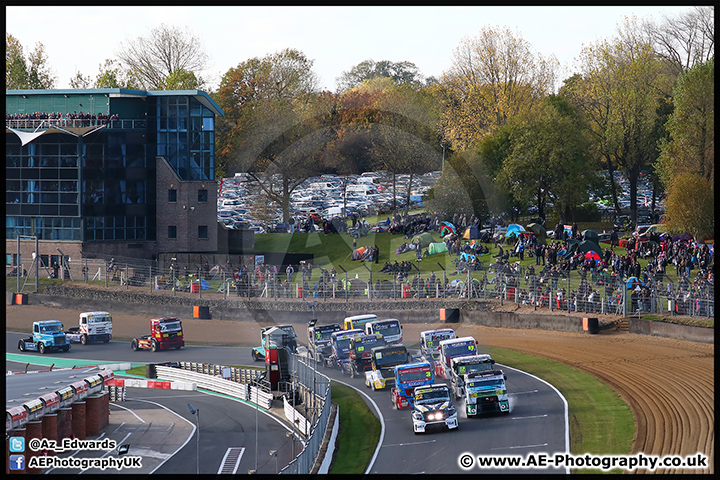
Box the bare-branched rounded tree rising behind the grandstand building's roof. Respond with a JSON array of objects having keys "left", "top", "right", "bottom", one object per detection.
[{"left": 117, "top": 24, "right": 208, "bottom": 90}]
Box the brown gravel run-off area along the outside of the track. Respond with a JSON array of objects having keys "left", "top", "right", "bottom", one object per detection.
[{"left": 6, "top": 305, "right": 715, "bottom": 474}]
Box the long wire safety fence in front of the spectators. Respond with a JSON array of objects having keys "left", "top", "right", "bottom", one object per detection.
[{"left": 7, "top": 255, "right": 715, "bottom": 317}]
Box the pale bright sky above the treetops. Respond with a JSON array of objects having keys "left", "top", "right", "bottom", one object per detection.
[{"left": 5, "top": 6, "right": 691, "bottom": 91}]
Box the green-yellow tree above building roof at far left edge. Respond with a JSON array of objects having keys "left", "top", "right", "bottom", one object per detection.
[{"left": 5, "top": 32, "right": 57, "bottom": 90}]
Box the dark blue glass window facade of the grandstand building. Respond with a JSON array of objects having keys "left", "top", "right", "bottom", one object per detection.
[{"left": 5, "top": 89, "right": 221, "bottom": 246}]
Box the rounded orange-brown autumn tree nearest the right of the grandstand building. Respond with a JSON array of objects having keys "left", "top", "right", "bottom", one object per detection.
[{"left": 214, "top": 49, "right": 322, "bottom": 221}]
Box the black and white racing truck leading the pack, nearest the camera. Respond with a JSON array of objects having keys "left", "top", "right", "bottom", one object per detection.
[{"left": 412, "top": 383, "right": 458, "bottom": 435}]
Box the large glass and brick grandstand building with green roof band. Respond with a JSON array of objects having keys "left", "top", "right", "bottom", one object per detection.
[{"left": 5, "top": 88, "right": 223, "bottom": 268}]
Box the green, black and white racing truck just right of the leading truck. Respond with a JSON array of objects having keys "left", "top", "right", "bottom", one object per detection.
[{"left": 465, "top": 370, "right": 510, "bottom": 417}]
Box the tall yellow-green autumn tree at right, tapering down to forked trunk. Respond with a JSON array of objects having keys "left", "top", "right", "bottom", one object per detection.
[{"left": 561, "top": 19, "right": 675, "bottom": 221}]
